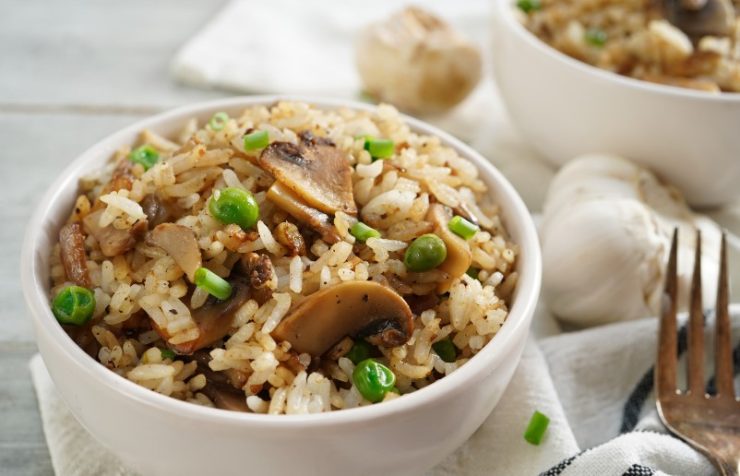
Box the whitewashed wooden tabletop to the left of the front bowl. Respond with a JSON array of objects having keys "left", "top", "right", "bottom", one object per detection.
[{"left": 0, "top": 0, "right": 224, "bottom": 476}]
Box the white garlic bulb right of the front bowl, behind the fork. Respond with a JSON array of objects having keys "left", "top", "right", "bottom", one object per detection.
[{"left": 540, "top": 155, "right": 721, "bottom": 326}]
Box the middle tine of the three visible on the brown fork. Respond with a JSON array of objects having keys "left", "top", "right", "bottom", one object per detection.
[{"left": 687, "top": 230, "right": 705, "bottom": 398}]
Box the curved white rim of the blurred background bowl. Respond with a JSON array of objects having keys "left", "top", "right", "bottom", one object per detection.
[{"left": 494, "top": 0, "right": 740, "bottom": 103}]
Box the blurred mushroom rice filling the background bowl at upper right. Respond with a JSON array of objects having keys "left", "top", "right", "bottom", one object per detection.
[{"left": 516, "top": 0, "right": 740, "bottom": 93}]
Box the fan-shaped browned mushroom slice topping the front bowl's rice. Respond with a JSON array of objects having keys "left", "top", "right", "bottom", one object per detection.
[{"left": 258, "top": 132, "right": 357, "bottom": 215}]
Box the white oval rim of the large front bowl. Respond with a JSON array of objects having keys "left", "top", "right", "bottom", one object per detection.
[{"left": 21, "top": 95, "right": 542, "bottom": 428}]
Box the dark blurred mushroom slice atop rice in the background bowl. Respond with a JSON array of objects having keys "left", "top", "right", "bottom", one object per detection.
[{"left": 663, "top": 0, "right": 735, "bottom": 41}]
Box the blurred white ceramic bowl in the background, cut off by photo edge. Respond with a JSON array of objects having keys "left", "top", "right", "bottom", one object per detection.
[{"left": 492, "top": 0, "right": 740, "bottom": 206}]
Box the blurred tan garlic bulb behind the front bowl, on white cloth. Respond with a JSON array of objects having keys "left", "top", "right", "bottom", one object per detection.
[{"left": 355, "top": 7, "right": 482, "bottom": 113}]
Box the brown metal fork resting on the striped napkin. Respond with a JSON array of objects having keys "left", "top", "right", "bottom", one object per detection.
[{"left": 655, "top": 230, "right": 740, "bottom": 476}]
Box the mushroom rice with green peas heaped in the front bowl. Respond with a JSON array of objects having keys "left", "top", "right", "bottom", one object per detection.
[{"left": 50, "top": 102, "right": 518, "bottom": 414}]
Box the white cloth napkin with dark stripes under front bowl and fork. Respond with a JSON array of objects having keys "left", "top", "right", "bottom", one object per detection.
[{"left": 31, "top": 307, "right": 740, "bottom": 476}]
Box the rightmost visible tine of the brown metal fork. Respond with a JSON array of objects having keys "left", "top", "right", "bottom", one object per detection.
[{"left": 714, "top": 233, "right": 735, "bottom": 399}]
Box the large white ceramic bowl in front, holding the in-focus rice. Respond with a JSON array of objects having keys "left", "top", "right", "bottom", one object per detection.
[{"left": 21, "top": 97, "right": 541, "bottom": 475}]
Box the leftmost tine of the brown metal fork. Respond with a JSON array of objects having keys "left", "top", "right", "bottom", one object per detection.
[{"left": 655, "top": 229, "right": 678, "bottom": 399}]
